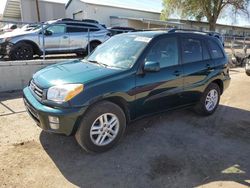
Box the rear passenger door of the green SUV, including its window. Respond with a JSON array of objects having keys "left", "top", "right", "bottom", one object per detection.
[{"left": 181, "top": 36, "right": 214, "bottom": 103}]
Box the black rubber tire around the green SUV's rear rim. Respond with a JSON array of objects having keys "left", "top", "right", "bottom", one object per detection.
[{"left": 194, "top": 83, "right": 221, "bottom": 116}]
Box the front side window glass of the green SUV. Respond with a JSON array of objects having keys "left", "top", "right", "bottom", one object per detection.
[{"left": 145, "top": 38, "right": 178, "bottom": 68}]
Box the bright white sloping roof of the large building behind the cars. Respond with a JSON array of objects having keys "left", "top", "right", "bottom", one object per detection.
[{"left": 66, "top": 0, "right": 162, "bottom": 14}]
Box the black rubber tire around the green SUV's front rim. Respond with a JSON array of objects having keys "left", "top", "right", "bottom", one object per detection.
[{"left": 75, "top": 101, "right": 126, "bottom": 153}]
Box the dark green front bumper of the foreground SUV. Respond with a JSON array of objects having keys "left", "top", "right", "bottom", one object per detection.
[{"left": 23, "top": 87, "right": 87, "bottom": 135}]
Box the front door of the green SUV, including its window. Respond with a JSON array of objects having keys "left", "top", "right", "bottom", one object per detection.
[{"left": 136, "top": 36, "right": 183, "bottom": 116}]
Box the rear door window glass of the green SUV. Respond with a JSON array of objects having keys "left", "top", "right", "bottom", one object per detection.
[{"left": 182, "top": 38, "right": 203, "bottom": 63}]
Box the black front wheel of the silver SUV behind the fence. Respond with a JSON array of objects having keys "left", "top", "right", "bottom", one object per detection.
[{"left": 9, "top": 42, "right": 34, "bottom": 60}]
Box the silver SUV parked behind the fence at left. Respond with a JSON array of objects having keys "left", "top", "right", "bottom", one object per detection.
[{"left": 0, "top": 19, "right": 110, "bottom": 60}]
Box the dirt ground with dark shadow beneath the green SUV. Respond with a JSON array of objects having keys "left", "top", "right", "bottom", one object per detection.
[{"left": 0, "top": 69, "right": 250, "bottom": 188}]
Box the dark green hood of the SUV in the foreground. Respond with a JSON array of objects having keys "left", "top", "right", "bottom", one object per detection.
[{"left": 33, "top": 60, "right": 121, "bottom": 88}]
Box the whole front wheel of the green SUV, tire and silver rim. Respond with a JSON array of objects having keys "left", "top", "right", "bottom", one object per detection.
[{"left": 75, "top": 101, "right": 126, "bottom": 152}]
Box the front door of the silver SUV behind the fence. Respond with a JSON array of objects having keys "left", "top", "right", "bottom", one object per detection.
[{"left": 41, "top": 24, "right": 69, "bottom": 52}]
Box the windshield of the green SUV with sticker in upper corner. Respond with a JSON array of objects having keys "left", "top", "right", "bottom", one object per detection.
[{"left": 87, "top": 35, "right": 151, "bottom": 69}]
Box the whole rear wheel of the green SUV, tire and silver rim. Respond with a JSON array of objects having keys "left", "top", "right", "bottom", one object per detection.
[{"left": 194, "top": 83, "right": 221, "bottom": 115}]
